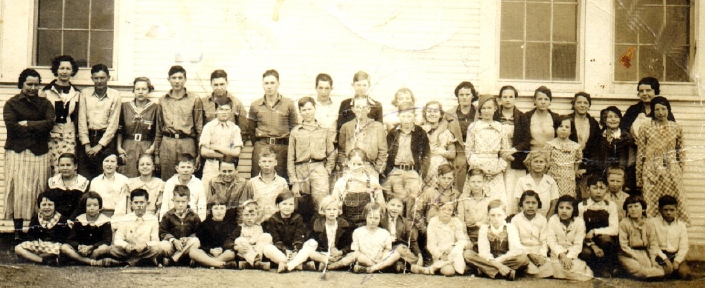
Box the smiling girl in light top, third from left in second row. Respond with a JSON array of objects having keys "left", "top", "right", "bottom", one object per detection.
[{"left": 127, "top": 154, "right": 164, "bottom": 215}]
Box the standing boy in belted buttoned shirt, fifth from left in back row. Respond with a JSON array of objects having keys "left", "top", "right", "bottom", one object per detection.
[{"left": 154, "top": 65, "right": 205, "bottom": 181}]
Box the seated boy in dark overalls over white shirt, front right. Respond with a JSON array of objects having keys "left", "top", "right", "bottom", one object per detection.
[{"left": 578, "top": 175, "right": 619, "bottom": 278}]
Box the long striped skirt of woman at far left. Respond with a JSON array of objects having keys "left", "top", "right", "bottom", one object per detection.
[{"left": 5, "top": 149, "right": 51, "bottom": 220}]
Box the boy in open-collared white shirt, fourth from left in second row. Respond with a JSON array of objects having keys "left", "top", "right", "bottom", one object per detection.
[{"left": 159, "top": 154, "right": 207, "bottom": 219}]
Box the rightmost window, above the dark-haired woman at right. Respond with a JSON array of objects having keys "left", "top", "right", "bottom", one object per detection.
[{"left": 614, "top": 0, "right": 694, "bottom": 82}]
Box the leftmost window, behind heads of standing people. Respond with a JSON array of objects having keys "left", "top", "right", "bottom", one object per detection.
[{"left": 34, "top": 0, "right": 115, "bottom": 68}]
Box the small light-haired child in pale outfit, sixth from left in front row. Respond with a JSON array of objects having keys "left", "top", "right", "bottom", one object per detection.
[{"left": 223, "top": 200, "right": 276, "bottom": 271}]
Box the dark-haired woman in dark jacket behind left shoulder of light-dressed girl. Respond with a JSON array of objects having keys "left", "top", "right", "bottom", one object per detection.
[{"left": 445, "top": 81, "right": 480, "bottom": 189}]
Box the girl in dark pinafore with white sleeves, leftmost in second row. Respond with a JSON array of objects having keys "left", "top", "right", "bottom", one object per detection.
[{"left": 49, "top": 153, "right": 90, "bottom": 221}]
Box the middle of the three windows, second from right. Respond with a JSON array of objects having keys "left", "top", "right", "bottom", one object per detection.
[{"left": 499, "top": 0, "right": 579, "bottom": 81}]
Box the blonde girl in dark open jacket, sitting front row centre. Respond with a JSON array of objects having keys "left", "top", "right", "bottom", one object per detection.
[{"left": 306, "top": 195, "right": 355, "bottom": 270}]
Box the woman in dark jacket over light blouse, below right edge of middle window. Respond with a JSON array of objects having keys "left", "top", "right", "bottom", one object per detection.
[{"left": 513, "top": 86, "right": 558, "bottom": 169}]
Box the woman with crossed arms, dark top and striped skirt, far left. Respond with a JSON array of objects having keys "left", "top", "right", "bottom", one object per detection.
[{"left": 3, "top": 69, "right": 56, "bottom": 240}]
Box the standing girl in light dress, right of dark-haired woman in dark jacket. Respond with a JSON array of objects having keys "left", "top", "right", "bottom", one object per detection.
[{"left": 463, "top": 96, "right": 511, "bottom": 203}]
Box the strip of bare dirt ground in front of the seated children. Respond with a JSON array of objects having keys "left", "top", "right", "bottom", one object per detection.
[{"left": 0, "top": 234, "right": 705, "bottom": 288}]
